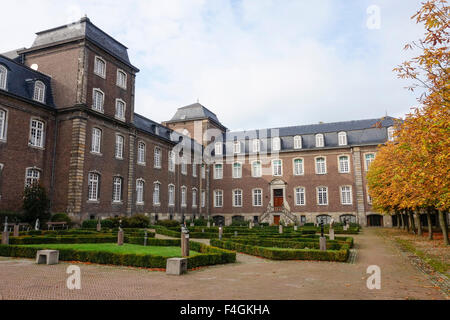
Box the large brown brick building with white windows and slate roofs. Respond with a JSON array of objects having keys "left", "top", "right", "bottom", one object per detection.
[{"left": 0, "top": 18, "right": 393, "bottom": 225}]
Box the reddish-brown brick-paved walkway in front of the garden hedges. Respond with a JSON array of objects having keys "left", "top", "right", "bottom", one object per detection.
[{"left": 0, "top": 229, "right": 446, "bottom": 300}]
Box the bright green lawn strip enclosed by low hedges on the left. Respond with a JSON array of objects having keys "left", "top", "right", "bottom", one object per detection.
[{"left": 21, "top": 243, "right": 199, "bottom": 258}]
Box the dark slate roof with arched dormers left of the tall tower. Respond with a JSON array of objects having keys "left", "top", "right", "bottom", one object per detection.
[{"left": 0, "top": 55, "right": 55, "bottom": 108}]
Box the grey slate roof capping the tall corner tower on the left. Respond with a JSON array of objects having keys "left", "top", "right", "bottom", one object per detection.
[{"left": 19, "top": 17, "right": 139, "bottom": 71}]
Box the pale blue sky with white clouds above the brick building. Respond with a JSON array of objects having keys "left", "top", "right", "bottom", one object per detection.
[{"left": 0, "top": 0, "right": 423, "bottom": 130}]
